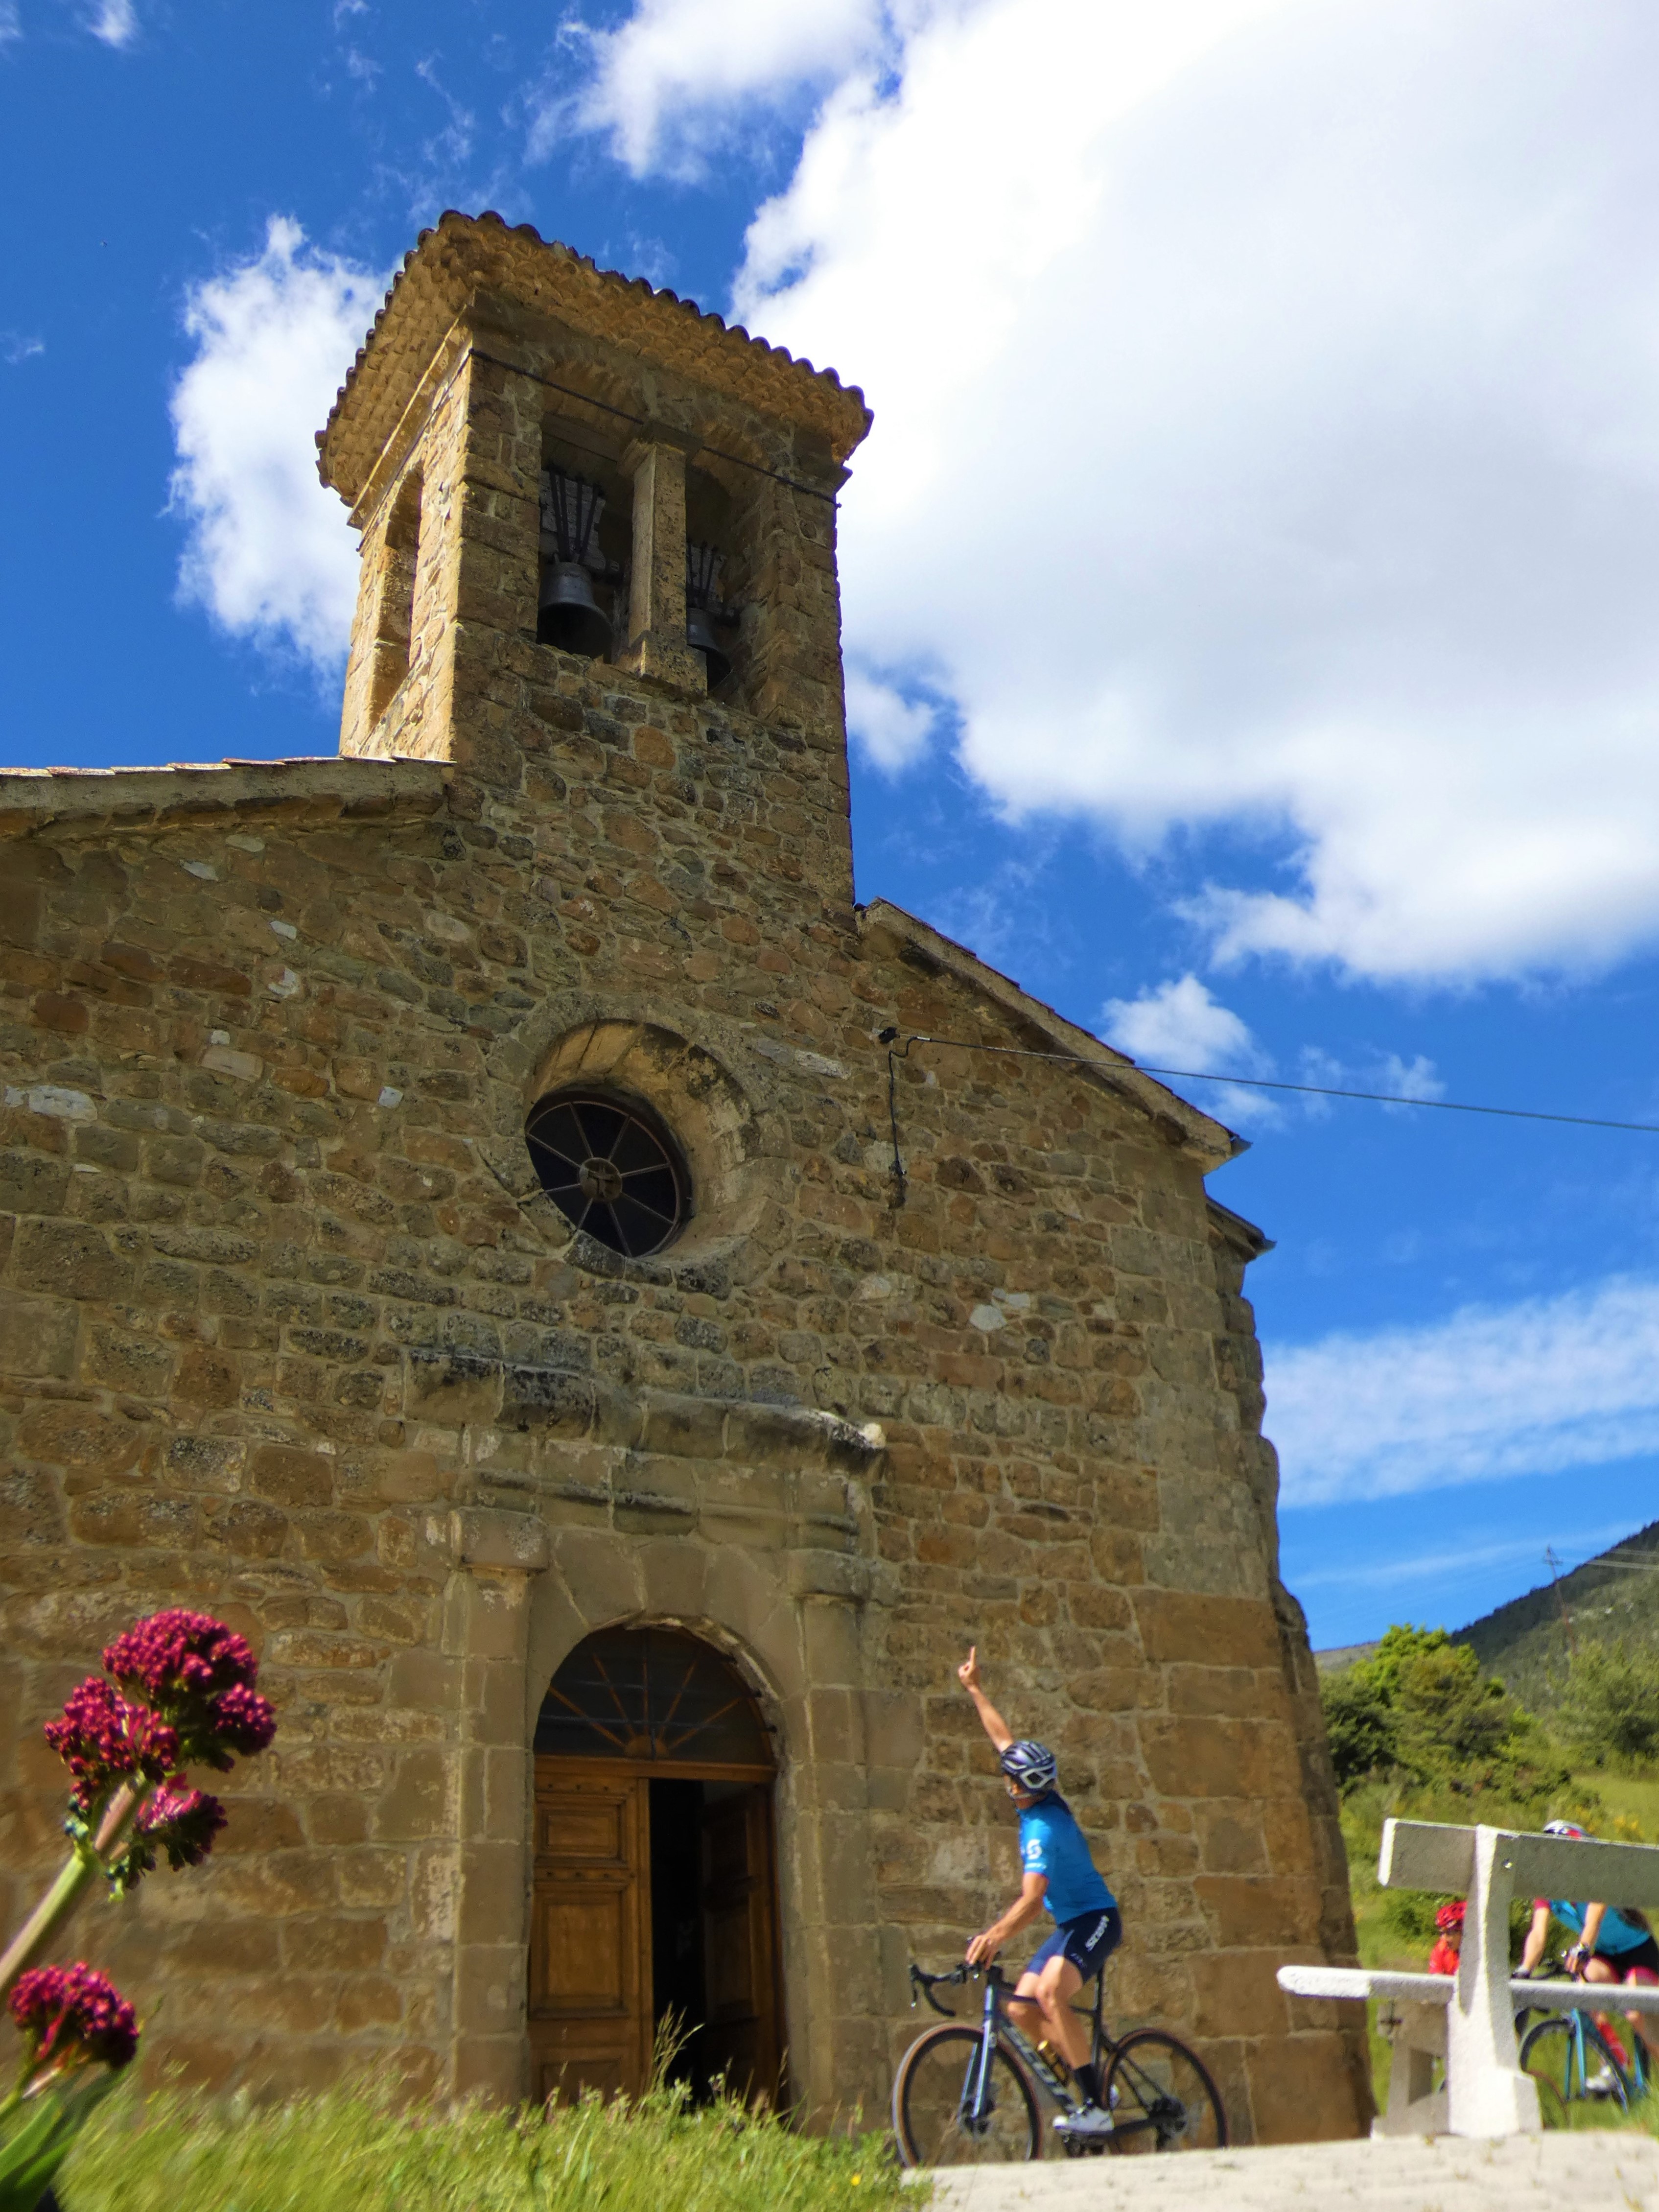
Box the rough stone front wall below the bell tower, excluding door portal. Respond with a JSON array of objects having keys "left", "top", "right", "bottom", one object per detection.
[{"left": 0, "top": 681, "right": 1358, "bottom": 2132}]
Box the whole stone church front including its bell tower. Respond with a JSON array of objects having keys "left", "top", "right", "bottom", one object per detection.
[{"left": 0, "top": 214, "right": 1369, "bottom": 2139}]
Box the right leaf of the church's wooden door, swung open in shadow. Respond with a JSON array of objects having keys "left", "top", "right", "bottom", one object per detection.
[{"left": 703, "top": 1785, "right": 783, "bottom": 2101}]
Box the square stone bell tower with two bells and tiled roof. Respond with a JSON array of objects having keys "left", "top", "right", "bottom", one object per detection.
[{"left": 319, "top": 214, "right": 869, "bottom": 900}]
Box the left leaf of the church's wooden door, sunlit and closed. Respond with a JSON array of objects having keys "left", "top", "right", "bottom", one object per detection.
[{"left": 529, "top": 1759, "right": 650, "bottom": 2101}]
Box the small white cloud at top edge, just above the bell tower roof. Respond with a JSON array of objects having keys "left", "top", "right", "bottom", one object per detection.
[{"left": 561, "top": 0, "right": 885, "bottom": 175}]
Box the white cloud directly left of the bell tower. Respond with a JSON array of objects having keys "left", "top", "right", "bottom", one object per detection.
[{"left": 170, "top": 217, "right": 385, "bottom": 672}]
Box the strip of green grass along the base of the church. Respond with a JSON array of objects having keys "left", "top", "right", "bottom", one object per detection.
[{"left": 57, "top": 2093, "right": 911, "bottom": 2212}]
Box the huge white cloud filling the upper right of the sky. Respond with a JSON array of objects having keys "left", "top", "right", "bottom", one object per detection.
[{"left": 690, "top": 0, "right": 1659, "bottom": 978}]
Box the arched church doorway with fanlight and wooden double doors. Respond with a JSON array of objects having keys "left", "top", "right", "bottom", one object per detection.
[{"left": 529, "top": 1628, "right": 783, "bottom": 2099}]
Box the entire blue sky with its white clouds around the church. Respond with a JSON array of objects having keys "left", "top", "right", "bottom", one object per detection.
[{"left": 0, "top": 0, "right": 1659, "bottom": 1644}]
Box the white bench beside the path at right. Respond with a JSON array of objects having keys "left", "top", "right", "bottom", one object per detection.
[{"left": 1279, "top": 1820, "right": 1659, "bottom": 2137}]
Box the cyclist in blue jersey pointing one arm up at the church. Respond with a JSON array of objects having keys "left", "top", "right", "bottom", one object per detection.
[{"left": 956, "top": 1648, "right": 1123, "bottom": 2141}]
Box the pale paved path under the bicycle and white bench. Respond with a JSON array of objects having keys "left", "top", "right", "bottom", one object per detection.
[{"left": 934, "top": 2132, "right": 1659, "bottom": 2212}]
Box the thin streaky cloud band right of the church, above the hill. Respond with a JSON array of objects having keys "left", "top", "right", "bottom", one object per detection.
[{"left": 1265, "top": 1276, "right": 1659, "bottom": 1506}]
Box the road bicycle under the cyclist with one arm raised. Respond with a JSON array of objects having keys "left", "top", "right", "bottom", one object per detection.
[{"left": 894, "top": 1964, "right": 1228, "bottom": 2165}]
